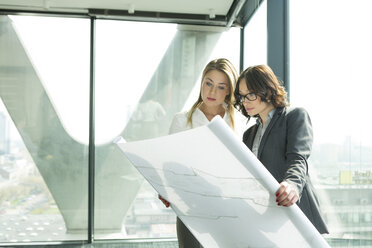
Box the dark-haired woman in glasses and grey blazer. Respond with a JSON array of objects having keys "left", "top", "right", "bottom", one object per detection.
[{"left": 234, "top": 65, "right": 328, "bottom": 233}]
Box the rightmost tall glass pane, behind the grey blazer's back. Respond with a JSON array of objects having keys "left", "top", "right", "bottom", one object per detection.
[{"left": 290, "top": 0, "right": 372, "bottom": 244}]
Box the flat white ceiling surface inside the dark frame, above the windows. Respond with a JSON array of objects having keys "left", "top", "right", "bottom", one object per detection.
[{"left": 0, "top": 0, "right": 234, "bottom": 16}]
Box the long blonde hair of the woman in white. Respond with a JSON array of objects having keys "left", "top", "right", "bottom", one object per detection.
[{"left": 187, "top": 58, "right": 238, "bottom": 130}]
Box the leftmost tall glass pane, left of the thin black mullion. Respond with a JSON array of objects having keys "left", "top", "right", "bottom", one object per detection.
[{"left": 0, "top": 16, "right": 89, "bottom": 243}]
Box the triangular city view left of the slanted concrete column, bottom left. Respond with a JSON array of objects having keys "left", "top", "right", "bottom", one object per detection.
[{"left": 0, "top": 102, "right": 66, "bottom": 244}]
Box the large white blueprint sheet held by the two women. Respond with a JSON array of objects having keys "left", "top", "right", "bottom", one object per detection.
[{"left": 117, "top": 117, "right": 329, "bottom": 248}]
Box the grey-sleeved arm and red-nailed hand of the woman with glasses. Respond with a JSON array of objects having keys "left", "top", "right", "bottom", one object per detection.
[{"left": 277, "top": 108, "right": 313, "bottom": 206}]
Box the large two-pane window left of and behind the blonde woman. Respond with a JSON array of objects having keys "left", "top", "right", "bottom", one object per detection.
[{"left": 0, "top": 12, "right": 240, "bottom": 245}]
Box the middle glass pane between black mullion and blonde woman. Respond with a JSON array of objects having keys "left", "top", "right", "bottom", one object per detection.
[{"left": 95, "top": 20, "right": 239, "bottom": 239}]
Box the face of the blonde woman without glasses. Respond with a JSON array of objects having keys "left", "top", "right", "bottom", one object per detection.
[{"left": 201, "top": 70, "right": 230, "bottom": 107}]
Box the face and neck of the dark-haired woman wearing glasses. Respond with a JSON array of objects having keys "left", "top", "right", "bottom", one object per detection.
[{"left": 239, "top": 78, "right": 274, "bottom": 120}]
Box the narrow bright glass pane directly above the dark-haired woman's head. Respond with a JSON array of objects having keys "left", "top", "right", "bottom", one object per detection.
[{"left": 244, "top": 1, "right": 267, "bottom": 69}]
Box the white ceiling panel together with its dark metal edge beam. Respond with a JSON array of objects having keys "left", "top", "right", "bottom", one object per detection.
[{"left": 0, "top": 0, "right": 262, "bottom": 27}]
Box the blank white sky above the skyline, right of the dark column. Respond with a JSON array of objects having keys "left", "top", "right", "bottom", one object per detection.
[{"left": 290, "top": 0, "right": 372, "bottom": 145}]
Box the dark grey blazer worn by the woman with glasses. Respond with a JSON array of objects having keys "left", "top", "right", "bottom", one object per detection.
[{"left": 243, "top": 108, "right": 328, "bottom": 233}]
